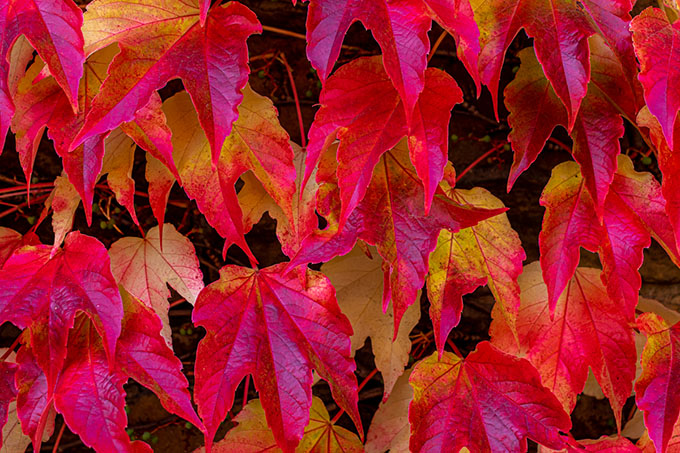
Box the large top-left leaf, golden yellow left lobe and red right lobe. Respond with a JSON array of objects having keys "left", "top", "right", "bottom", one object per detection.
[{"left": 71, "top": 0, "right": 262, "bottom": 163}]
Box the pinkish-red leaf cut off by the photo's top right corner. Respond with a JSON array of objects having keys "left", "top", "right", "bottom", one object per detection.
[{"left": 630, "top": 7, "right": 680, "bottom": 151}]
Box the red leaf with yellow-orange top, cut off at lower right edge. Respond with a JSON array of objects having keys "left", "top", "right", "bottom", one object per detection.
[{"left": 635, "top": 313, "right": 680, "bottom": 452}]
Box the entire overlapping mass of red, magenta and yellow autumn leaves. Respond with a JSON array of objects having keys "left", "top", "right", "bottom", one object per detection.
[{"left": 0, "top": 0, "right": 680, "bottom": 452}]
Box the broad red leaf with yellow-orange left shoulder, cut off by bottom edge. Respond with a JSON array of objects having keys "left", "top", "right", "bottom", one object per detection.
[{"left": 409, "top": 342, "right": 571, "bottom": 452}]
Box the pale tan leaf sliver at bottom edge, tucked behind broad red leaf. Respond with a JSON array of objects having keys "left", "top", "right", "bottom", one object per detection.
[{"left": 365, "top": 369, "right": 413, "bottom": 453}]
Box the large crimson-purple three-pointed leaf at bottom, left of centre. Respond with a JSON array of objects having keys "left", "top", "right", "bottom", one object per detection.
[{"left": 193, "top": 264, "right": 361, "bottom": 451}]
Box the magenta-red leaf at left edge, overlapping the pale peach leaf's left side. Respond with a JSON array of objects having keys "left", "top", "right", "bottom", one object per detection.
[{"left": 0, "top": 232, "right": 123, "bottom": 389}]
